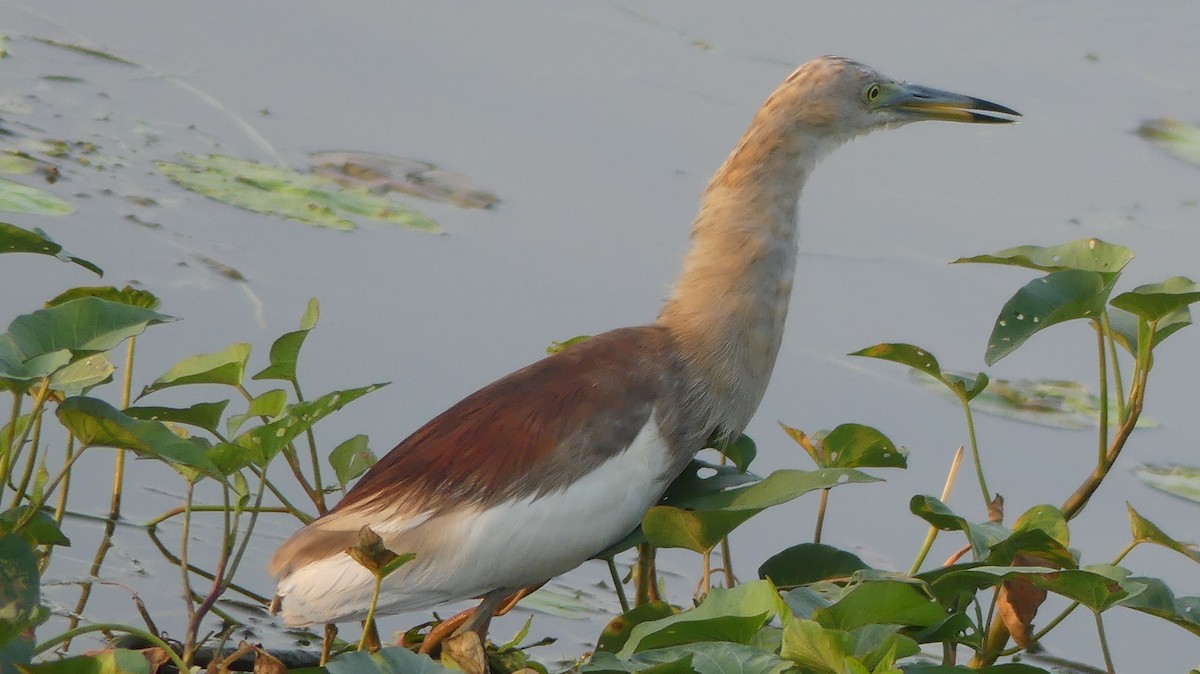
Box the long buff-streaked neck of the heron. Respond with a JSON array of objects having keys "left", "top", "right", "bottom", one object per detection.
[{"left": 658, "top": 99, "right": 832, "bottom": 437}]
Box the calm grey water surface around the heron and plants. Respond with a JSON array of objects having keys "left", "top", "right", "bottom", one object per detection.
[{"left": 7, "top": 0, "right": 1200, "bottom": 672}]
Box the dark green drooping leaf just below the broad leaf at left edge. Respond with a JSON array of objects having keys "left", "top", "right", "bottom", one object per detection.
[{"left": 58, "top": 396, "right": 217, "bottom": 475}]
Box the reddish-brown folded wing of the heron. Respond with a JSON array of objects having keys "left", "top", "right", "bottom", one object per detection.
[{"left": 335, "top": 326, "right": 674, "bottom": 512}]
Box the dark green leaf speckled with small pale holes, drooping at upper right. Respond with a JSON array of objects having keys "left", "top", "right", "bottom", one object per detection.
[{"left": 984, "top": 270, "right": 1117, "bottom": 365}]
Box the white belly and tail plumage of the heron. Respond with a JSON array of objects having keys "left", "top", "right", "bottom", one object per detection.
[{"left": 278, "top": 420, "right": 672, "bottom": 625}]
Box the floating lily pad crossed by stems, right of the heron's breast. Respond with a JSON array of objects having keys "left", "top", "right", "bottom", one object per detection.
[{"left": 914, "top": 374, "right": 1158, "bottom": 428}]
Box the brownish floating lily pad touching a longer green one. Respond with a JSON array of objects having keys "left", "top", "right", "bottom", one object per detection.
[{"left": 311, "top": 152, "right": 498, "bottom": 209}]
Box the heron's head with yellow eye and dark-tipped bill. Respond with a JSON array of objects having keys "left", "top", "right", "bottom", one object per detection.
[{"left": 768, "top": 56, "right": 1020, "bottom": 140}]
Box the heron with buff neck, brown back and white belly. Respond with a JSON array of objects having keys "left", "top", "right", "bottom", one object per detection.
[{"left": 270, "top": 56, "right": 1020, "bottom": 647}]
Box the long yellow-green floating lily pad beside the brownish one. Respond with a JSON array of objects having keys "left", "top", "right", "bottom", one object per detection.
[{"left": 155, "top": 154, "right": 440, "bottom": 231}]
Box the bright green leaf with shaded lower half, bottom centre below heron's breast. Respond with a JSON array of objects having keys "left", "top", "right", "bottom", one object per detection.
[{"left": 618, "top": 580, "right": 780, "bottom": 658}]
